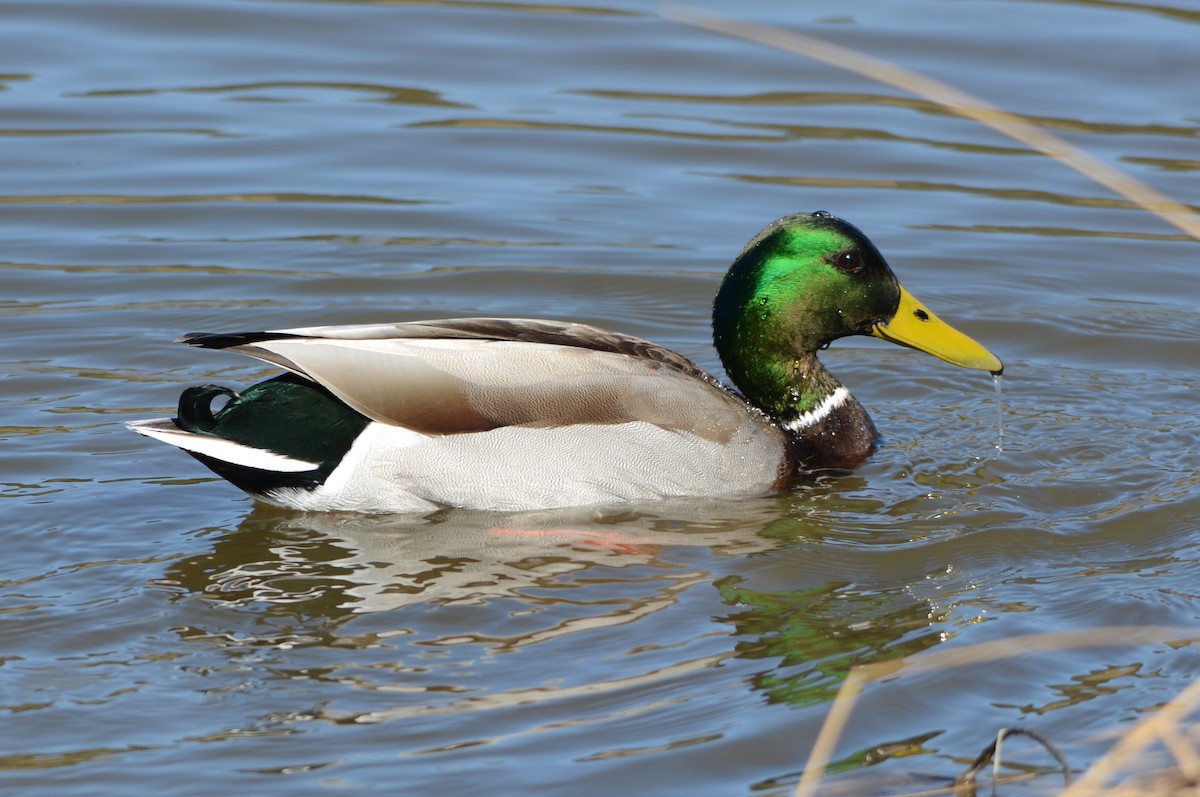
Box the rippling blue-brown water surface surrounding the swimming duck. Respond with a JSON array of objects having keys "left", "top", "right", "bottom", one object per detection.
[{"left": 0, "top": 0, "right": 1200, "bottom": 796}]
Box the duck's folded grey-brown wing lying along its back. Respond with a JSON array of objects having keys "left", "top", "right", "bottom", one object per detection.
[{"left": 184, "top": 318, "right": 767, "bottom": 441}]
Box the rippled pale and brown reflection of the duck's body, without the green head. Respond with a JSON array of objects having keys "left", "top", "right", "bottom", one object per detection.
[{"left": 168, "top": 499, "right": 779, "bottom": 615}]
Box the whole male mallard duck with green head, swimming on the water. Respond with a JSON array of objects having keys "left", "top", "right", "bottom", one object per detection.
[{"left": 130, "top": 211, "right": 1003, "bottom": 513}]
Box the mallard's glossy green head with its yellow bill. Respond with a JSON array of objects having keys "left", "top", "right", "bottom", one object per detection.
[{"left": 713, "top": 211, "right": 1003, "bottom": 412}]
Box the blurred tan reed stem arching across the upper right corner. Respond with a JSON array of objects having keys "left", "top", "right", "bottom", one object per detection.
[{"left": 662, "top": 4, "right": 1200, "bottom": 240}]
